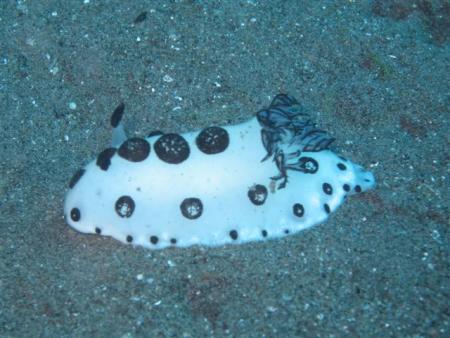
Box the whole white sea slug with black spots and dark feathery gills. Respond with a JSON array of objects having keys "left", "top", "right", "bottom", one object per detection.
[{"left": 64, "top": 94, "right": 375, "bottom": 248}]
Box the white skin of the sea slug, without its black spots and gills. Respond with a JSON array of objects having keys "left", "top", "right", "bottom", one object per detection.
[{"left": 64, "top": 118, "right": 375, "bottom": 248}]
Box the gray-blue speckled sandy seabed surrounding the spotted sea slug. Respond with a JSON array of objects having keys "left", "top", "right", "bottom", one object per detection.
[{"left": 0, "top": 0, "right": 450, "bottom": 337}]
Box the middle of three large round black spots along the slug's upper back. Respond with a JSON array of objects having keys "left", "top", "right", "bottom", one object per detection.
[{"left": 154, "top": 133, "right": 190, "bottom": 164}]
